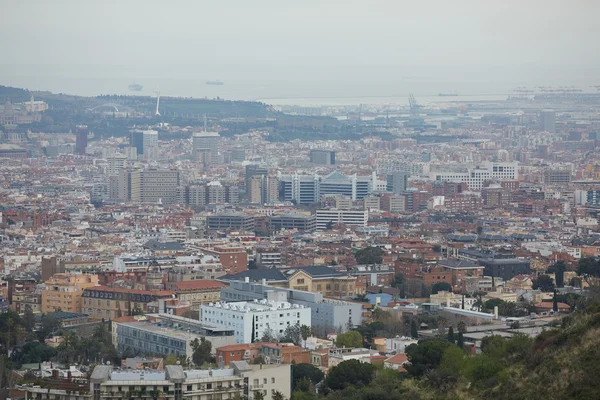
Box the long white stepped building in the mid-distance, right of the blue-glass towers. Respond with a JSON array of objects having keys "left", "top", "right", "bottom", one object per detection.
[{"left": 429, "top": 162, "right": 519, "bottom": 190}]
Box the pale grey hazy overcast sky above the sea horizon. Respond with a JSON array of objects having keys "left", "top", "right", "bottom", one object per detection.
[{"left": 0, "top": 0, "right": 600, "bottom": 97}]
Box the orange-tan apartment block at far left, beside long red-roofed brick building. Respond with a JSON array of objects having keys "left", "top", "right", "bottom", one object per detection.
[{"left": 42, "top": 273, "right": 98, "bottom": 314}]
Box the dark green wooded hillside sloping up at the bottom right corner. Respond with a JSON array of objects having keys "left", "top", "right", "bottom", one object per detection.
[{"left": 292, "top": 300, "right": 600, "bottom": 400}]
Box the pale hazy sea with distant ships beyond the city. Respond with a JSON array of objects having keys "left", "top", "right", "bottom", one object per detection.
[{"left": 0, "top": 64, "right": 597, "bottom": 106}]
